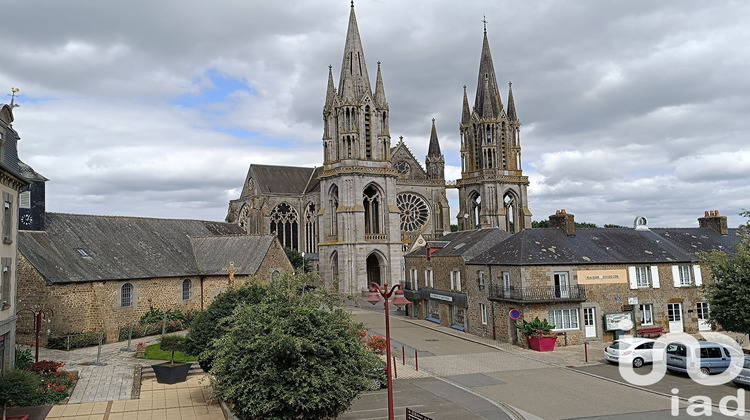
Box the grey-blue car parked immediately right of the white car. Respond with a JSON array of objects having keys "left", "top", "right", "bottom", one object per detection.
[{"left": 666, "top": 341, "right": 732, "bottom": 376}]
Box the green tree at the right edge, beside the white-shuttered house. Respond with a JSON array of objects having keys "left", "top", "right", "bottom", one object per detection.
[{"left": 701, "top": 233, "right": 750, "bottom": 342}]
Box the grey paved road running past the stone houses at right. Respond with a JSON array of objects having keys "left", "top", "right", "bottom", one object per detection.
[{"left": 340, "top": 310, "right": 744, "bottom": 420}]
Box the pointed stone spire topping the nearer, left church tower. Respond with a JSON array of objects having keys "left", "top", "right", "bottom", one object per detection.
[{"left": 339, "top": 2, "right": 372, "bottom": 104}]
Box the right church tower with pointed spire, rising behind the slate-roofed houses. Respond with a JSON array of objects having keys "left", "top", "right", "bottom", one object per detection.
[{"left": 456, "top": 24, "right": 531, "bottom": 232}]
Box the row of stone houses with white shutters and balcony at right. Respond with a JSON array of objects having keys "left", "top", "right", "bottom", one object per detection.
[{"left": 405, "top": 210, "right": 740, "bottom": 345}]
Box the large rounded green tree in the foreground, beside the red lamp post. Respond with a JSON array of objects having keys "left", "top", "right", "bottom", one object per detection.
[{"left": 210, "top": 274, "right": 380, "bottom": 419}]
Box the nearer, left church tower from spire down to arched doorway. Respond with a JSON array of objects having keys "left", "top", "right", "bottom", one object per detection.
[{"left": 318, "top": 2, "right": 401, "bottom": 293}]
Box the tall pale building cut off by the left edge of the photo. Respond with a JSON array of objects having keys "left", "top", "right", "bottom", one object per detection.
[{"left": 0, "top": 101, "right": 29, "bottom": 371}]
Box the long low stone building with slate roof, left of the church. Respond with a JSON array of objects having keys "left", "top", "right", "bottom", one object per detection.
[{"left": 18, "top": 213, "right": 292, "bottom": 342}]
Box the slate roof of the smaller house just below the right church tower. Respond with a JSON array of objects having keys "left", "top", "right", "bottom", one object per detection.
[{"left": 407, "top": 228, "right": 512, "bottom": 260}]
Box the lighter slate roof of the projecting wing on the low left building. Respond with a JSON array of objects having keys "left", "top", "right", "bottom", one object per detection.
[{"left": 190, "top": 235, "right": 274, "bottom": 275}]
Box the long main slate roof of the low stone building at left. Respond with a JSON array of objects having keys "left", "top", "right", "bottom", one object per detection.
[{"left": 18, "top": 213, "right": 251, "bottom": 283}]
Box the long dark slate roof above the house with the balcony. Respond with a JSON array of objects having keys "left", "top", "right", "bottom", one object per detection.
[{"left": 468, "top": 228, "right": 739, "bottom": 265}]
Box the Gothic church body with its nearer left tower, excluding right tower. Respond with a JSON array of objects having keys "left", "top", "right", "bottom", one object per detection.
[{"left": 226, "top": 5, "right": 450, "bottom": 293}]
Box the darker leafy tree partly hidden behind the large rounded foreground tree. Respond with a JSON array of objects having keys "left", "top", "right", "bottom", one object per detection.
[{"left": 184, "top": 280, "right": 266, "bottom": 372}]
